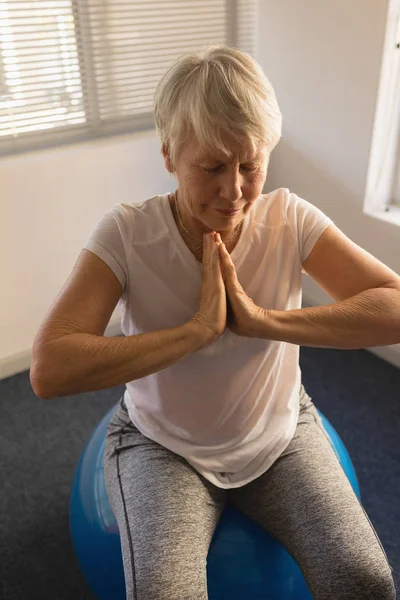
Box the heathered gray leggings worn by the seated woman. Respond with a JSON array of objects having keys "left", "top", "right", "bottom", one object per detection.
[{"left": 104, "top": 386, "right": 396, "bottom": 600}]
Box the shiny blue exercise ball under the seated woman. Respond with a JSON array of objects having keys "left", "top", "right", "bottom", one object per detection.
[{"left": 70, "top": 404, "right": 360, "bottom": 600}]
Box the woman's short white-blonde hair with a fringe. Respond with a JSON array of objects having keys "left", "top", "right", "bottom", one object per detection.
[{"left": 154, "top": 44, "right": 282, "bottom": 168}]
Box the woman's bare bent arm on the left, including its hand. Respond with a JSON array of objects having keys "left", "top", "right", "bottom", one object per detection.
[{"left": 30, "top": 235, "right": 226, "bottom": 399}]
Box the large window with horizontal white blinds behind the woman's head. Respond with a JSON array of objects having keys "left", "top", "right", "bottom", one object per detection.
[{"left": 0, "top": 0, "right": 257, "bottom": 154}]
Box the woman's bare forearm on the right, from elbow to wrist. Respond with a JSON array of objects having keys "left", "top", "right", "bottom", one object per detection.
[{"left": 255, "top": 288, "right": 400, "bottom": 350}]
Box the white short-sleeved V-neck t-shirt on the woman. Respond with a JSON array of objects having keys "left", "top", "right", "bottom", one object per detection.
[{"left": 84, "top": 188, "right": 332, "bottom": 488}]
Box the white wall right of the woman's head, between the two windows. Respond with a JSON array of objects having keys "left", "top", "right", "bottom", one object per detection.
[{"left": 258, "top": 0, "right": 400, "bottom": 366}]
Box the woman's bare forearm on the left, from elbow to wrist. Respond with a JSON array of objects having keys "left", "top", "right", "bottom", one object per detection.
[{"left": 31, "top": 322, "right": 207, "bottom": 399}]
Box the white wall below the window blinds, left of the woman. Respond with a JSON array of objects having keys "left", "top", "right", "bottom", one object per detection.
[{"left": 0, "top": 130, "right": 174, "bottom": 379}]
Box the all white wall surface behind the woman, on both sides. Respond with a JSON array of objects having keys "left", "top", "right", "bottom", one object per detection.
[{"left": 0, "top": 0, "right": 400, "bottom": 378}]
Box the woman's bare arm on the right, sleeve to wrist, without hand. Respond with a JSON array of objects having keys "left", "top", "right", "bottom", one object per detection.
[{"left": 252, "top": 225, "right": 400, "bottom": 350}]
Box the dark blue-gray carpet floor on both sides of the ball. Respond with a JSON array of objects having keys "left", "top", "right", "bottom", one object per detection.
[{"left": 0, "top": 348, "right": 400, "bottom": 600}]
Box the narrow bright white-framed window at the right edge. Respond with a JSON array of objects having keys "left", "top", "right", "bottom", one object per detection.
[{"left": 364, "top": 0, "right": 400, "bottom": 224}]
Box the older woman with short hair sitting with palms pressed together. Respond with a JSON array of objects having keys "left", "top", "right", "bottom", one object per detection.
[{"left": 31, "top": 46, "right": 400, "bottom": 600}]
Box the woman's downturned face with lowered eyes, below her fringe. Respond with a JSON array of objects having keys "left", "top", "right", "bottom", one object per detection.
[{"left": 163, "top": 137, "right": 270, "bottom": 233}]
